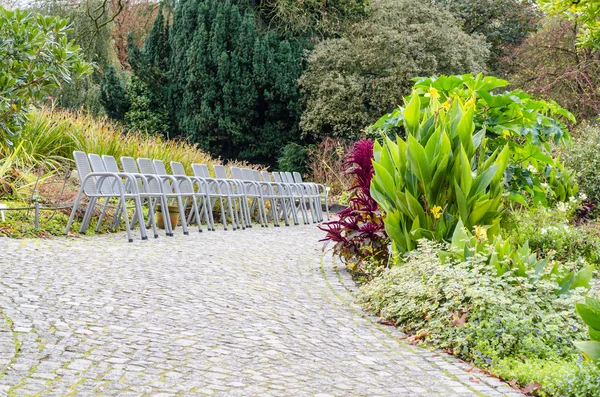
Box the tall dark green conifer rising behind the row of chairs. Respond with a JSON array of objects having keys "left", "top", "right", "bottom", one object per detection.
[{"left": 169, "top": 0, "right": 302, "bottom": 163}]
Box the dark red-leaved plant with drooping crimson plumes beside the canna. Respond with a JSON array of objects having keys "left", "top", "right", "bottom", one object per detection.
[{"left": 319, "top": 139, "right": 389, "bottom": 268}]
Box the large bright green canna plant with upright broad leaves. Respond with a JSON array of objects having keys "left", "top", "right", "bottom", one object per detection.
[{"left": 371, "top": 88, "right": 509, "bottom": 253}]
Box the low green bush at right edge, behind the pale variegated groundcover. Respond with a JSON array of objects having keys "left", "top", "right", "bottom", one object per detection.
[{"left": 505, "top": 204, "right": 600, "bottom": 264}]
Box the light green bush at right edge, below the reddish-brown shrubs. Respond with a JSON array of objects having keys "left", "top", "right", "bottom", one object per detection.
[{"left": 560, "top": 125, "right": 600, "bottom": 202}]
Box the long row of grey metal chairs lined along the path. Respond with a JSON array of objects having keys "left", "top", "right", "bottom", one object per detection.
[{"left": 65, "top": 151, "right": 329, "bottom": 242}]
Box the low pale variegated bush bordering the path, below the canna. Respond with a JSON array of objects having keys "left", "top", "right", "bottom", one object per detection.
[{"left": 362, "top": 240, "right": 599, "bottom": 397}]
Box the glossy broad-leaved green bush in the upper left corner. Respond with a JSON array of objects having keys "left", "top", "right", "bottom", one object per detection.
[{"left": 0, "top": 6, "right": 91, "bottom": 140}]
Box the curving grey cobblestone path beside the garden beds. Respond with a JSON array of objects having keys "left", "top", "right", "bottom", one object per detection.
[{"left": 0, "top": 226, "right": 520, "bottom": 397}]
